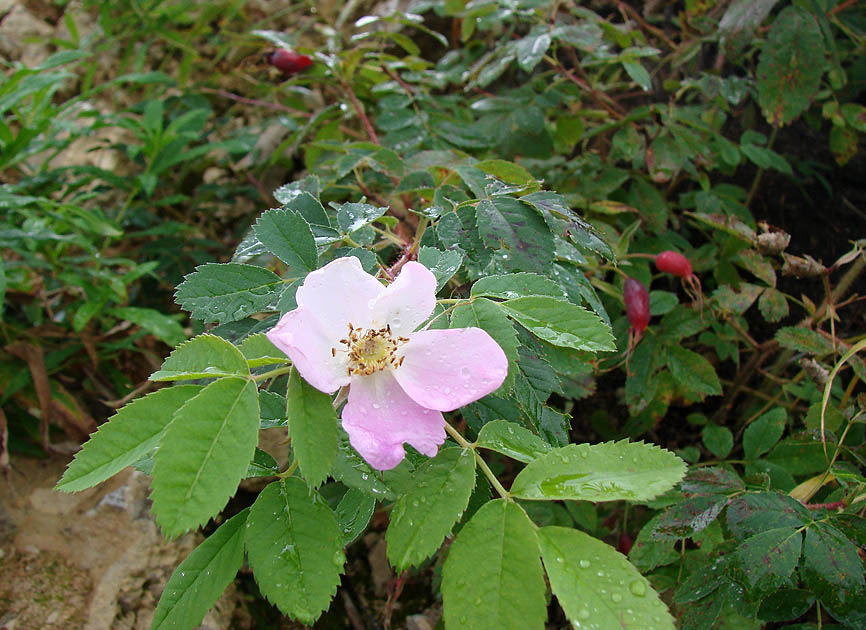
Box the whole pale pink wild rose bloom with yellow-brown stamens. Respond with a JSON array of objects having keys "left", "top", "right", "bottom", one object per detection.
[{"left": 267, "top": 257, "right": 508, "bottom": 470}]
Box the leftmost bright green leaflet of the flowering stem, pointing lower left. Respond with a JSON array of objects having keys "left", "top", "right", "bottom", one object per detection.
[{"left": 57, "top": 385, "right": 202, "bottom": 492}]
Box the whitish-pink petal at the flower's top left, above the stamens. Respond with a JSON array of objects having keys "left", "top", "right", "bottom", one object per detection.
[{"left": 295, "top": 256, "right": 385, "bottom": 340}]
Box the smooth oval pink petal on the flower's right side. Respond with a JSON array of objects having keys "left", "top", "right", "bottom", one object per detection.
[{"left": 394, "top": 328, "right": 508, "bottom": 411}]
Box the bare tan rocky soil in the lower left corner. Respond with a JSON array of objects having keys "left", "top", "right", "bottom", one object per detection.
[{"left": 0, "top": 457, "right": 243, "bottom": 630}]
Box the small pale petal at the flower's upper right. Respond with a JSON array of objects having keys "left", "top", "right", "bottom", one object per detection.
[{"left": 373, "top": 261, "right": 436, "bottom": 335}]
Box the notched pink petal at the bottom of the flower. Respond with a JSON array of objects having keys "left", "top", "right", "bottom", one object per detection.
[{"left": 342, "top": 370, "right": 445, "bottom": 470}]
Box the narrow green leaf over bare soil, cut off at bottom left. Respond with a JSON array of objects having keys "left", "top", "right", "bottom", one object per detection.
[{"left": 150, "top": 509, "right": 249, "bottom": 630}]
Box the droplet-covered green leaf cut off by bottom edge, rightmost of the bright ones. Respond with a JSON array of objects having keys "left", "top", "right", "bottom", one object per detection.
[{"left": 538, "top": 527, "right": 676, "bottom": 630}]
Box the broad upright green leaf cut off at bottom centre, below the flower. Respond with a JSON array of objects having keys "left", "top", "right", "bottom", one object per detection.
[{"left": 442, "top": 499, "right": 547, "bottom": 630}]
